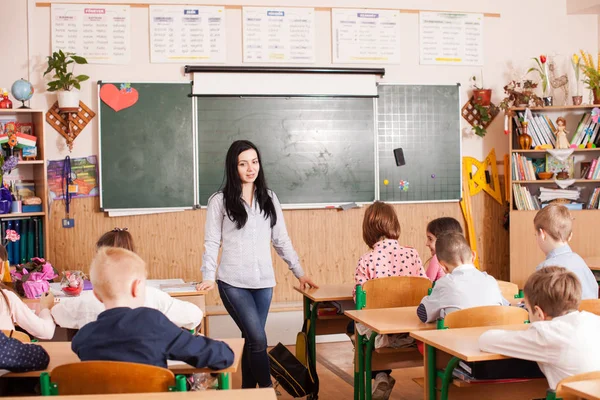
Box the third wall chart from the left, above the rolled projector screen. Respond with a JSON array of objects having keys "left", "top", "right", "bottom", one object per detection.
[{"left": 243, "top": 7, "right": 315, "bottom": 64}]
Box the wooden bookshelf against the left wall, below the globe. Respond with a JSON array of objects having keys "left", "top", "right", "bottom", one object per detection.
[{"left": 0, "top": 109, "right": 50, "bottom": 266}]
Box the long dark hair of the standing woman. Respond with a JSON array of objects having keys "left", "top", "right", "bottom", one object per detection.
[{"left": 223, "top": 140, "right": 277, "bottom": 229}]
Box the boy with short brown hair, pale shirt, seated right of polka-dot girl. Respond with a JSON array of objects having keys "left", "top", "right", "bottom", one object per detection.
[{"left": 417, "top": 232, "right": 508, "bottom": 322}]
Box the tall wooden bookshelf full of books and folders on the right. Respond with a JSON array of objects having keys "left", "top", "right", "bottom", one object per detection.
[{"left": 507, "top": 105, "right": 600, "bottom": 288}]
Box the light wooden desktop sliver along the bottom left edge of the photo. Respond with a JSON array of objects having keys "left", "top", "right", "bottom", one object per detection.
[{"left": 3, "top": 388, "right": 277, "bottom": 400}]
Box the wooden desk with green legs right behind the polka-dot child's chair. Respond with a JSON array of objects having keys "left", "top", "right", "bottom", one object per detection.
[{"left": 344, "top": 307, "right": 436, "bottom": 399}]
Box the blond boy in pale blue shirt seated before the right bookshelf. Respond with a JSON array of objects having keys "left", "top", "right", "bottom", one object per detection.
[{"left": 533, "top": 204, "right": 598, "bottom": 299}]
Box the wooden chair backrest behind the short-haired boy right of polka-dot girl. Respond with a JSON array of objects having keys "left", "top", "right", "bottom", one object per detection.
[{"left": 444, "top": 305, "right": 529, "bottom": 329}]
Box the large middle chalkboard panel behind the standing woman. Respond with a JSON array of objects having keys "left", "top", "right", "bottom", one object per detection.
[{"left": 197, "top": 97, "right": 375, "bottom": 205}]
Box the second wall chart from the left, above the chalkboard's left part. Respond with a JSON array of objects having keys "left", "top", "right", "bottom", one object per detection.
[{"left": 149, "top": 5, "right": 226, "bottom": 63}]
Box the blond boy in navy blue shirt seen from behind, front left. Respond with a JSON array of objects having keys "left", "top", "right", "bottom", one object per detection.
[{"left": 71, "top": 247, "right": 233, "bottom": 370}]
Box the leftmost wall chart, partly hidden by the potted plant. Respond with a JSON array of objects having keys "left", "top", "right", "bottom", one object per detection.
[{"left": 50, "top": 4, "right": 131, "bottom": 64}]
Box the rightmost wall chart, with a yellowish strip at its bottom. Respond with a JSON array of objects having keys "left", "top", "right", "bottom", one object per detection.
[{"left": 419, "top": 12, "right": 483, "bottom": 65}]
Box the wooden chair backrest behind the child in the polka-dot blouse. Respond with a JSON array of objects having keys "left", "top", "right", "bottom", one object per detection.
[{"left": 362, "top": 276, "right": 431, "bottom": 309}]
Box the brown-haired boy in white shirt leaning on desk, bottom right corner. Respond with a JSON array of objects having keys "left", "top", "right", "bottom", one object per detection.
[{"left": 479, "top": 266, "right": 600, "bottom": 389}]
